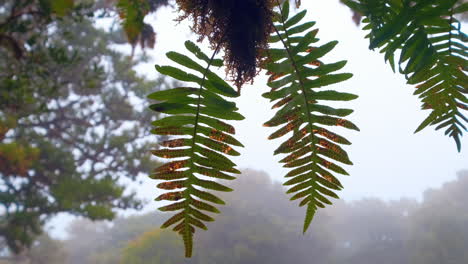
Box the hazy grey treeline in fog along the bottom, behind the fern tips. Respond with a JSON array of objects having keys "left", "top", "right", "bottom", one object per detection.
[{"left": 21, "top": 170, "right": 468, "bottom": 264}]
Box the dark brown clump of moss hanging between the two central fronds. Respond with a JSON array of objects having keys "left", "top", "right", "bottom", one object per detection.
[{"left": 177, "top": 0, "right": 274, "bottom": 89}]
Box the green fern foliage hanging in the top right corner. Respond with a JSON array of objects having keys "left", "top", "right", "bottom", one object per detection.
[{"left": 345, "top": 0, "right": 468, "bottom": 151}]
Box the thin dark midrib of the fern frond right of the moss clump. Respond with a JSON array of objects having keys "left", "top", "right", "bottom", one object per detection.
[{"left": 273, "top": 0, "right": 317, "bottom": 198}]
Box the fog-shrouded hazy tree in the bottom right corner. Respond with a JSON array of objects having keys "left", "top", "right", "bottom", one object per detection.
[{"left": 409, "top": 170, "right": 468, "bottom": 264}]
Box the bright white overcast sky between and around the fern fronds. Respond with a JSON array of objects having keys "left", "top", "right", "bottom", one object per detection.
[{"left": 49, "top": 0, "right": 468, "bottom": 238}]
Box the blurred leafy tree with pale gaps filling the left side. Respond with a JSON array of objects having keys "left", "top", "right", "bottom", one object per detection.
[{"left": 0, "top": 0, "right": 167, "bottom": 253}]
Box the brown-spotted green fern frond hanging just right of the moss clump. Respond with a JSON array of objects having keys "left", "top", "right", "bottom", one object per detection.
[{"left": 263, "top": 1, "right": 359, "bottom": 232}]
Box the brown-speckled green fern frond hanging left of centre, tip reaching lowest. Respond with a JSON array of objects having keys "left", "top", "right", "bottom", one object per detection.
[{"left": 148, "top": 41, "right": 244, "bottom": 257}]
